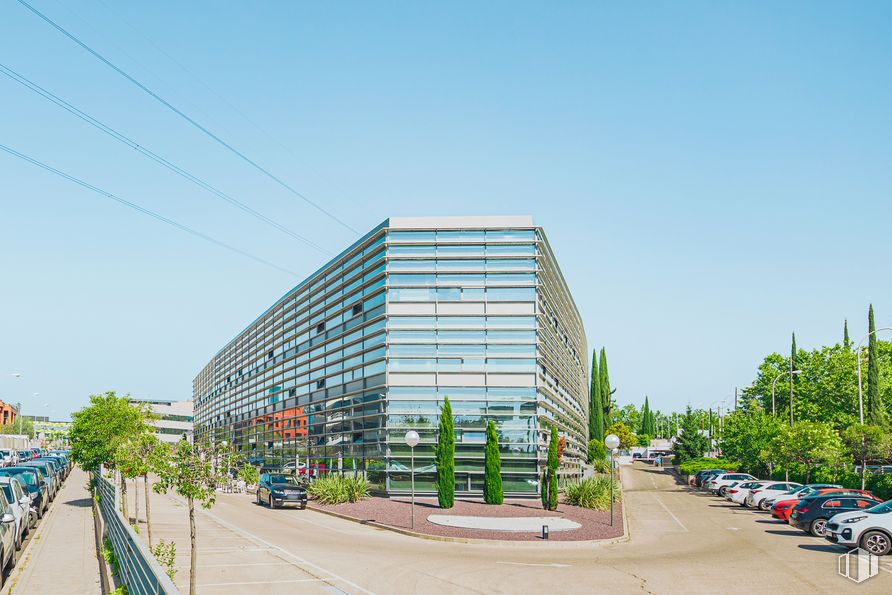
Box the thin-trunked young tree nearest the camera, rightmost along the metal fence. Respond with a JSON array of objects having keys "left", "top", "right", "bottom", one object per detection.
[{"left": 152, "top": 440, "right": 233, "bottom": 595}]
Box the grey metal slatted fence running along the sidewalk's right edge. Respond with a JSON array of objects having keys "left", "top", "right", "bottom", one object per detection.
[{"left": 93, "top": 473, "right": 179, "bottom": 595}]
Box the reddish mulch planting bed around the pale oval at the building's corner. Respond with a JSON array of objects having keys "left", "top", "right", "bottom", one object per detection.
[{"left": 310, "top": 497, "right": 623, "bottom": 541}]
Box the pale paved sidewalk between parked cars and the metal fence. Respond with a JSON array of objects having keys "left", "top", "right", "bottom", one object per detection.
[{"left": 2, "top": 467, "right": 101, "bottom": 595}]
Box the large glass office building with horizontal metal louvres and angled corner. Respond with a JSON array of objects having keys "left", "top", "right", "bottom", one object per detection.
[{"left": 193, "top": 217, "right": 588, "bottom": 494}]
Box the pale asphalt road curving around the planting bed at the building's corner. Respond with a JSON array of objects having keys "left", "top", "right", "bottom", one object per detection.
[{"left": 178, "top": 464, "right": 892, "bottom": 594}]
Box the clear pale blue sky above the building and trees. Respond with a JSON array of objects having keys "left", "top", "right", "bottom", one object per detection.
[{"left": 0, "top": 0, "right": 892, "bottom": 419}]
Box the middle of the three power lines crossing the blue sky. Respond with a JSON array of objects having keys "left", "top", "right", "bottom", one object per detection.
[{"left": 0, "top": 63, "right": 331, "bottom": 255}]
